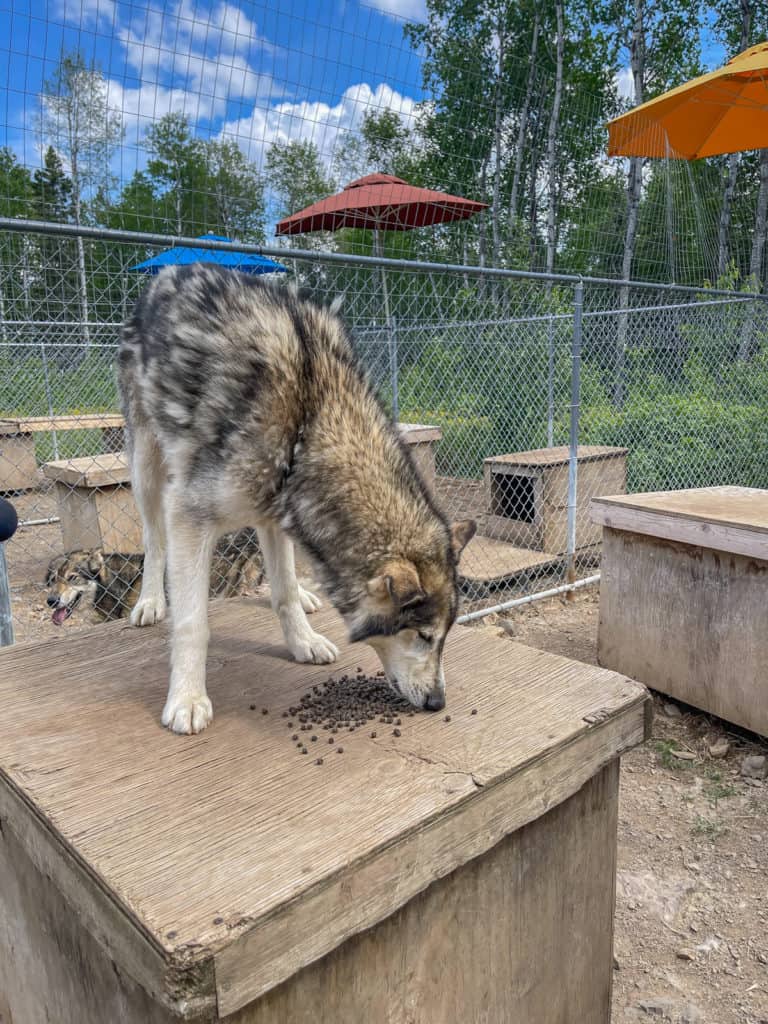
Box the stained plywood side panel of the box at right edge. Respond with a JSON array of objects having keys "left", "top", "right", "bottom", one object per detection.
[{"left": 598, "top": 528, "right": 768, "bottom": 735}]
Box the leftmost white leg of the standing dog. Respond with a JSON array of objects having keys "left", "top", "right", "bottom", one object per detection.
[{"left": 130, "top": 428, "right": 166, "bottom": 626}]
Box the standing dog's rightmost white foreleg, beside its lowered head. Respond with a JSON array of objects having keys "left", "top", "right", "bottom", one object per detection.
[{"left": 258, "top": 524, "right": 339, "bottom": 665}]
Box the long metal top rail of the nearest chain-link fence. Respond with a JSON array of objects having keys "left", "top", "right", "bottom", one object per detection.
[{"left": 0, "top": 217, "right": 768, "bottom": 302}]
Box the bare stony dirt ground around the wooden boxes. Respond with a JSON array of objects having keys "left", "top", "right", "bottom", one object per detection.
[{"left": 7, "top": 512, "right": 768, "bottom": 1024}]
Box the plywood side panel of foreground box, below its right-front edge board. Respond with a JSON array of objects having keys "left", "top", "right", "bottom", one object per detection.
[{"left": 228, "top": 762, "right": 618, "bottom": 1024}]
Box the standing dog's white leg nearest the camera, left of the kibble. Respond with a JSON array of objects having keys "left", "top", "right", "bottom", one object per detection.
[{"left": 162, "top": 487, "right": 218, "bottom": 733}]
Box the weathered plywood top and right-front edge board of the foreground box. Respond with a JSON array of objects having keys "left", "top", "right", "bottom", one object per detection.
[{"left": 0, "top": 600, "right": 647, "bottom": 1012}]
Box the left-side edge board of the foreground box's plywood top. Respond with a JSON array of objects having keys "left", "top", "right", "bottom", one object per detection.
[{"left": 0, "top": 770, "right": 216, "bottom": 1021}]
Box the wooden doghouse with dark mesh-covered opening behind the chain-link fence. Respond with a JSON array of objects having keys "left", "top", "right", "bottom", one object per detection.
[{"left": 482, "top": 445, "right": 627, "bottom": 553}]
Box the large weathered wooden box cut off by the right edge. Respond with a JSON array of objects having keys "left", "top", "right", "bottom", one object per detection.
[{"left": 592, "top": 487, "right": 768, "bottom": 735}]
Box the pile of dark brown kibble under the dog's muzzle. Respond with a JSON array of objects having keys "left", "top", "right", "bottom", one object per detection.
[{"left": 283, "top": 669, "right": 416, "bottom": 764}]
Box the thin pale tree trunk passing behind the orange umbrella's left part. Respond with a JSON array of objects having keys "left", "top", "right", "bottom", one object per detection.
[{"left": 613, "top": 0, "right": 645, "bottom": 409}]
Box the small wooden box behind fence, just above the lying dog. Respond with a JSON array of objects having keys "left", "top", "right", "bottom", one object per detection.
[{"left": 43, "top": 453, "right": 143, "bottom": 553}]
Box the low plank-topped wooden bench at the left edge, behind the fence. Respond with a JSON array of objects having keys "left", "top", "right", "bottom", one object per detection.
[{"left": 0, "top": 413, "right": 125, "bottom": 494}]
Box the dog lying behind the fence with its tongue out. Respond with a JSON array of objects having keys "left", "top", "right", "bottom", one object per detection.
[{"left": 45, "top": 529, "right": 263, "bottom": 626}]
